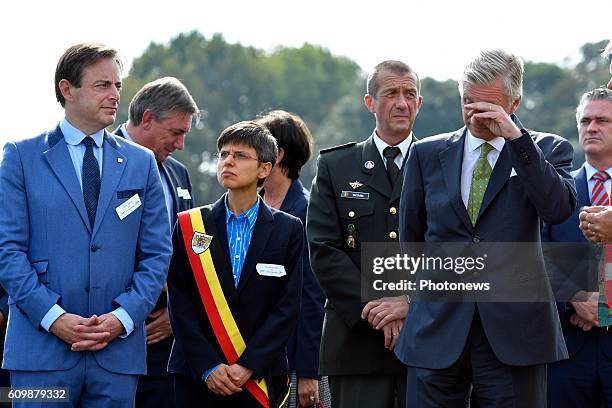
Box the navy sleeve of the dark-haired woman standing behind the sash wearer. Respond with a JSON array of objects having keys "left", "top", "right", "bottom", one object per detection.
[{"left": 288, "top": 202, "right": 325, "bottom": 379}]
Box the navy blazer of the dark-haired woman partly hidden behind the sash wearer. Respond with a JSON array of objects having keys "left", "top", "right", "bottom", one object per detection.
[{"left": 261, "top": 180, "right": 325, "bottom": 378}]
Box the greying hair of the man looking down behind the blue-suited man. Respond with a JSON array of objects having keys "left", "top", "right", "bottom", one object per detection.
[{"left": 129, "top": 77, "right": 200, "bottom": 126}]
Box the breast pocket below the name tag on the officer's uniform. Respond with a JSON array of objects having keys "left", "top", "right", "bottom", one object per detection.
[{"left": 338, "top": 199, "right": 380, "bottom": 251}]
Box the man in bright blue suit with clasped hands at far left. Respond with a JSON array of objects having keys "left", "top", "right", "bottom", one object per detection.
[{"left": 0, "top": 44, "right": 171, "bottom": 407}]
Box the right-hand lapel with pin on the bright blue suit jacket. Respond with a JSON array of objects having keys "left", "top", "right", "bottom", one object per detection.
[{"left": 92, "top": 131, "right": 127, "bottom": 237}]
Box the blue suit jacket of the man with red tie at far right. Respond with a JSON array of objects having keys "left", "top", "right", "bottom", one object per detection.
[{"left": 542, "top": 165, "right": 612, "bottom": 358}]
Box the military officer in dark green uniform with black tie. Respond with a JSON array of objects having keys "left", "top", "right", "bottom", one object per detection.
[{"left": 306, "top": 61, "right": 422, "bottom": 408}]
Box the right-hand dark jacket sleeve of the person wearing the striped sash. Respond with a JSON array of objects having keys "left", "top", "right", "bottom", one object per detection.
[{"left": 236, "top": 218, "right": 304, "bottom": 378}]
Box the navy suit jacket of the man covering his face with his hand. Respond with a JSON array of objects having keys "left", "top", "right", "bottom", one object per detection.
[{"left": 395, "top": 123, "right": 576, "bottom": 369}]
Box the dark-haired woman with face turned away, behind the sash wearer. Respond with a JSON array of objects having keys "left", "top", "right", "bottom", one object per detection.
[{"left": 258, "top": 110, "right": 331, "bottom": 408}]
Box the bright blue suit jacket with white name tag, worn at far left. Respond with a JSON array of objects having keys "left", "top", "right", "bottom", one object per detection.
[{"left": 0, "top": 127, "right": 171, "bottom": 374}]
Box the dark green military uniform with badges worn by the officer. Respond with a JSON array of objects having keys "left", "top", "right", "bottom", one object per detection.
[{"left": 306, "top": 135, "right": 412, "bottom": 407}]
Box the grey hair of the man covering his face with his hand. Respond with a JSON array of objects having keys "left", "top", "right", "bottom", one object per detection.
[{"left": 459, "top": 49, "right": 525, "bottom": 101}]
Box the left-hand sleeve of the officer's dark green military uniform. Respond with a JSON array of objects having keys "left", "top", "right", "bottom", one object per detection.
[{"left": 306, "top": 155, "right": 365, "bottom": 327}]
